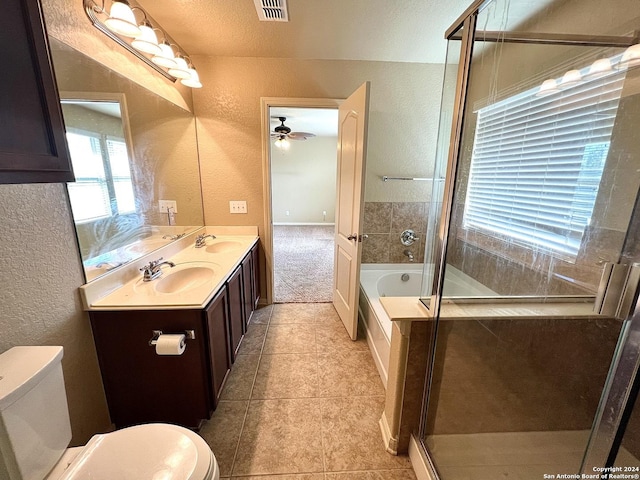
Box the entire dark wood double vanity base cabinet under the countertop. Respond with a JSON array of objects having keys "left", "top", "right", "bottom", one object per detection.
[{"left": 89, "top": 242, "right": 259, "bottom": 429}]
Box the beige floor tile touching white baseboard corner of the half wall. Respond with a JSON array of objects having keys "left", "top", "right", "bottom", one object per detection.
[{"left": 322, "top": 397, "right": 411, "bottom": 470}]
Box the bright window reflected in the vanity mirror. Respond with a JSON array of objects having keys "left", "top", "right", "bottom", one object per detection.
[{"left": 67, "top": 129, "right": 135, "bottom": 222}]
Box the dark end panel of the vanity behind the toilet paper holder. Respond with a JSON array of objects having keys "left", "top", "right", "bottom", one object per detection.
[{"left": 90, "top": 309, "right": 218, "bottom": 428}]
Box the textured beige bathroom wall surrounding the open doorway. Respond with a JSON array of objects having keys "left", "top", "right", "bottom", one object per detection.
[{"left": 194, "top": 57, "right": 443, "bottom": 232}]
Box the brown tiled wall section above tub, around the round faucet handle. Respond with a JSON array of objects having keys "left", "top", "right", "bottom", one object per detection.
[{"left": 362, "top": 202, "right": 429, "bottom": 263}]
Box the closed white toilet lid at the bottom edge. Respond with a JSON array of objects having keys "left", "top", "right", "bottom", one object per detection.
[{"left": 60, "top": 423, "right": 217, "bottom": 480}]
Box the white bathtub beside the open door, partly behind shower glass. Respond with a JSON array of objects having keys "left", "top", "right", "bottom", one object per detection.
[{"left": 358, "top": 263, "right": 497, "bottom": 388}]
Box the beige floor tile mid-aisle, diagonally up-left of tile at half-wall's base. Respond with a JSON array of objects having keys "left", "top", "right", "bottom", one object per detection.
[{"left": 251, "top": 353, "right": 318, "bottom": 399}]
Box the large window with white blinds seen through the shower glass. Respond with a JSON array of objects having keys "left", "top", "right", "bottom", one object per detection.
[{"left": 463, "top": 68, "right": 624, "bottom": 259}]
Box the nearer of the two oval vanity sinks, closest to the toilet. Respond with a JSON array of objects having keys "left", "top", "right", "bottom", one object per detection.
[{"left": 136, "top": 263, "right": 220, "bottom": 293}]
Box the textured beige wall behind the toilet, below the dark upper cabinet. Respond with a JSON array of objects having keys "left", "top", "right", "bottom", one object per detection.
[{"left": 0, "top": 184, "right": 110, "bottom": 444}]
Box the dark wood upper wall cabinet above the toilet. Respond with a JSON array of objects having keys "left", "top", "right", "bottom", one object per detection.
[{"left": 0, "top": 0, "right": 74, "bottom": 183}]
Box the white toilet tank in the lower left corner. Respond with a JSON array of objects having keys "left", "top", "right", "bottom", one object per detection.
[{"left": 0, "top": 347, "right": 71, "bottom": 480}]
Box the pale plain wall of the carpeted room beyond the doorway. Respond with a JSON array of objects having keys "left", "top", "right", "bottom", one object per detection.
[{"left": 271, "top": 137, "right": 338, "bottom": 223}]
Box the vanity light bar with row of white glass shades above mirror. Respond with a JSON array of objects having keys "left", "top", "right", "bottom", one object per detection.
[{"left": 83, "top": 0, "right": 202, "bottom": 88}]
